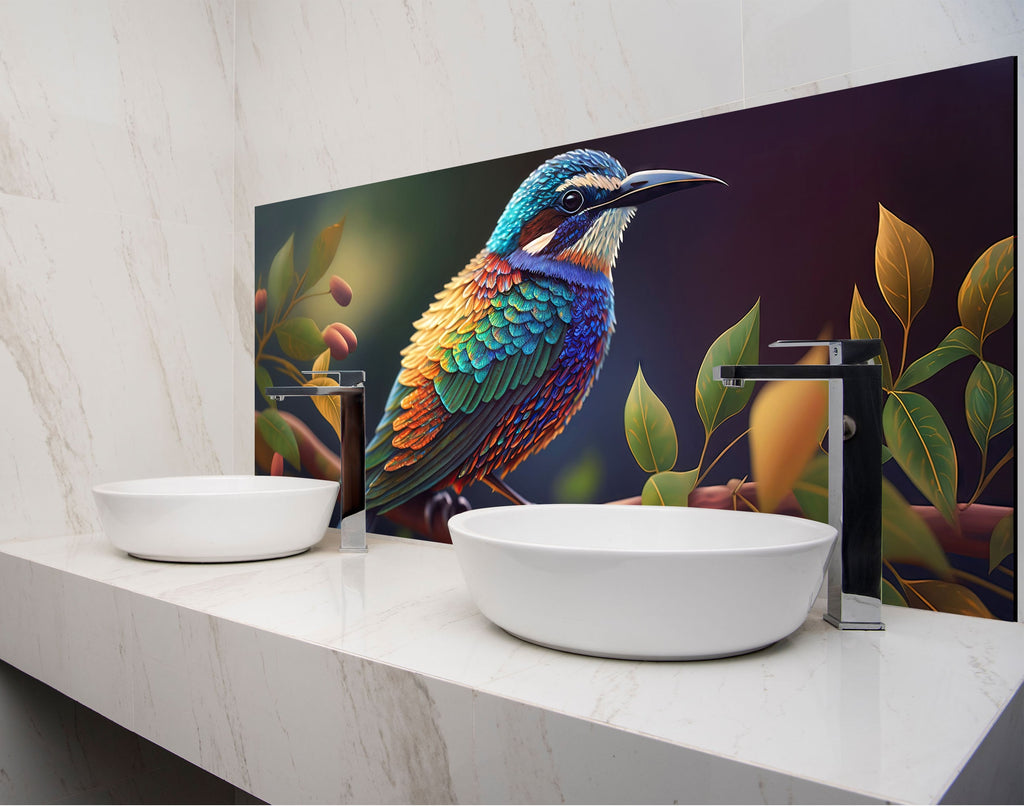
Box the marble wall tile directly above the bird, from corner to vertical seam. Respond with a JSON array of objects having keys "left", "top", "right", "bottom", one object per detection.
[{"left": 236, "top": 0, "right": 740, "bottom": 204}]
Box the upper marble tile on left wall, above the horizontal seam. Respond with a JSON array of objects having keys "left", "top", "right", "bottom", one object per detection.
[{"left": 0, "top": 0, "right": 234, "bottom": 228}]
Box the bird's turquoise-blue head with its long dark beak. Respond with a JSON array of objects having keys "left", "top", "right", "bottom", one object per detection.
[{"left": 487, "top": 149, "right": 724, "bottom": 284}]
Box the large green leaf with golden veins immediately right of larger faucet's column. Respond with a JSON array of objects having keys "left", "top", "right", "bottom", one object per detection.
[{"left": 882, "top": 392, "right": 957, "bottom": 526}]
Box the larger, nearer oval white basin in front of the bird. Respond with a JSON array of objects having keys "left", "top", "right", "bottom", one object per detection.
[{"left": 449, "top": 504, "right": 836, "bottom": 661}]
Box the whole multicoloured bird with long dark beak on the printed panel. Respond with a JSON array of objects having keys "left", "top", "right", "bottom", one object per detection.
[{"left": 367, "top": 150, "right": 724, "bottom": 512}]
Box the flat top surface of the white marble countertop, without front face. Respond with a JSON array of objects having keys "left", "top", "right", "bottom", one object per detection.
[{"left": 0, "top": 534, "right": 1024, "bottom": 802}]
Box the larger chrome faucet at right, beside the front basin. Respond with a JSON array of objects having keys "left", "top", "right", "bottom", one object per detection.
[{"left": 714, "top": 339, "right": 885, "bottom": 630}]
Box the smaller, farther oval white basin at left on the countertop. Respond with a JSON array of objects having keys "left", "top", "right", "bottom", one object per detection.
[{"left": 92, "top": 476, "right": 338, "bottom": 562}]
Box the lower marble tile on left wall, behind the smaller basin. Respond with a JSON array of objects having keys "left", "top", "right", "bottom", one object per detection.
[{"left": 0, "top": 196, "right": 233, "bottom": 539}]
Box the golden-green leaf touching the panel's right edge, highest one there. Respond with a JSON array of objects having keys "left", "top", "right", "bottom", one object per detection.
[{"left": 956, "top": 236, "right": 1016, "bottom": 344}]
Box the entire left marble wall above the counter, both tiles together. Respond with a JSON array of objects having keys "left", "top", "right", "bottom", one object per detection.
[{"left": 0, "top": 0, "right": 236, "bottom": 540}]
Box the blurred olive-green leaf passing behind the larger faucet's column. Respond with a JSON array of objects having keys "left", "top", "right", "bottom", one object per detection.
[{"left": 793, "top": 456, "right": 952, "bottom": 578}]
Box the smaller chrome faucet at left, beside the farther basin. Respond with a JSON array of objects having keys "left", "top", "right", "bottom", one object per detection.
[{"left": 264, "top": 370, "right": 367, "bottom": 552}]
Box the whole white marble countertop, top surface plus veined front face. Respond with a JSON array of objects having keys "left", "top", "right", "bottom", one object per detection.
[{"left": 0, "top": 535, "right": 1024, "bottom": 803}]
